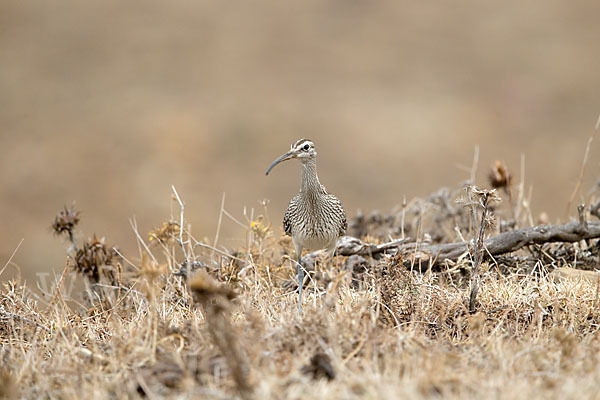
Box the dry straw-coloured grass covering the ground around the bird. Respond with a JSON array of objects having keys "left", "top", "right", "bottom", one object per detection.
[{"left": 0, "top": 188, "right": 600, "bottom": 399}]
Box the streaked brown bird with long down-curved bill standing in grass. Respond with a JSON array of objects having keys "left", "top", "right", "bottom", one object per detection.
[{"left": 266, "top": 139, "right": 348, "bottom": 314}]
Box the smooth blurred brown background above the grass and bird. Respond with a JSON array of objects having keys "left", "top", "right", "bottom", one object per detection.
[{"left": 0, "top": 0, "right": 600, "bottom": 280}]
